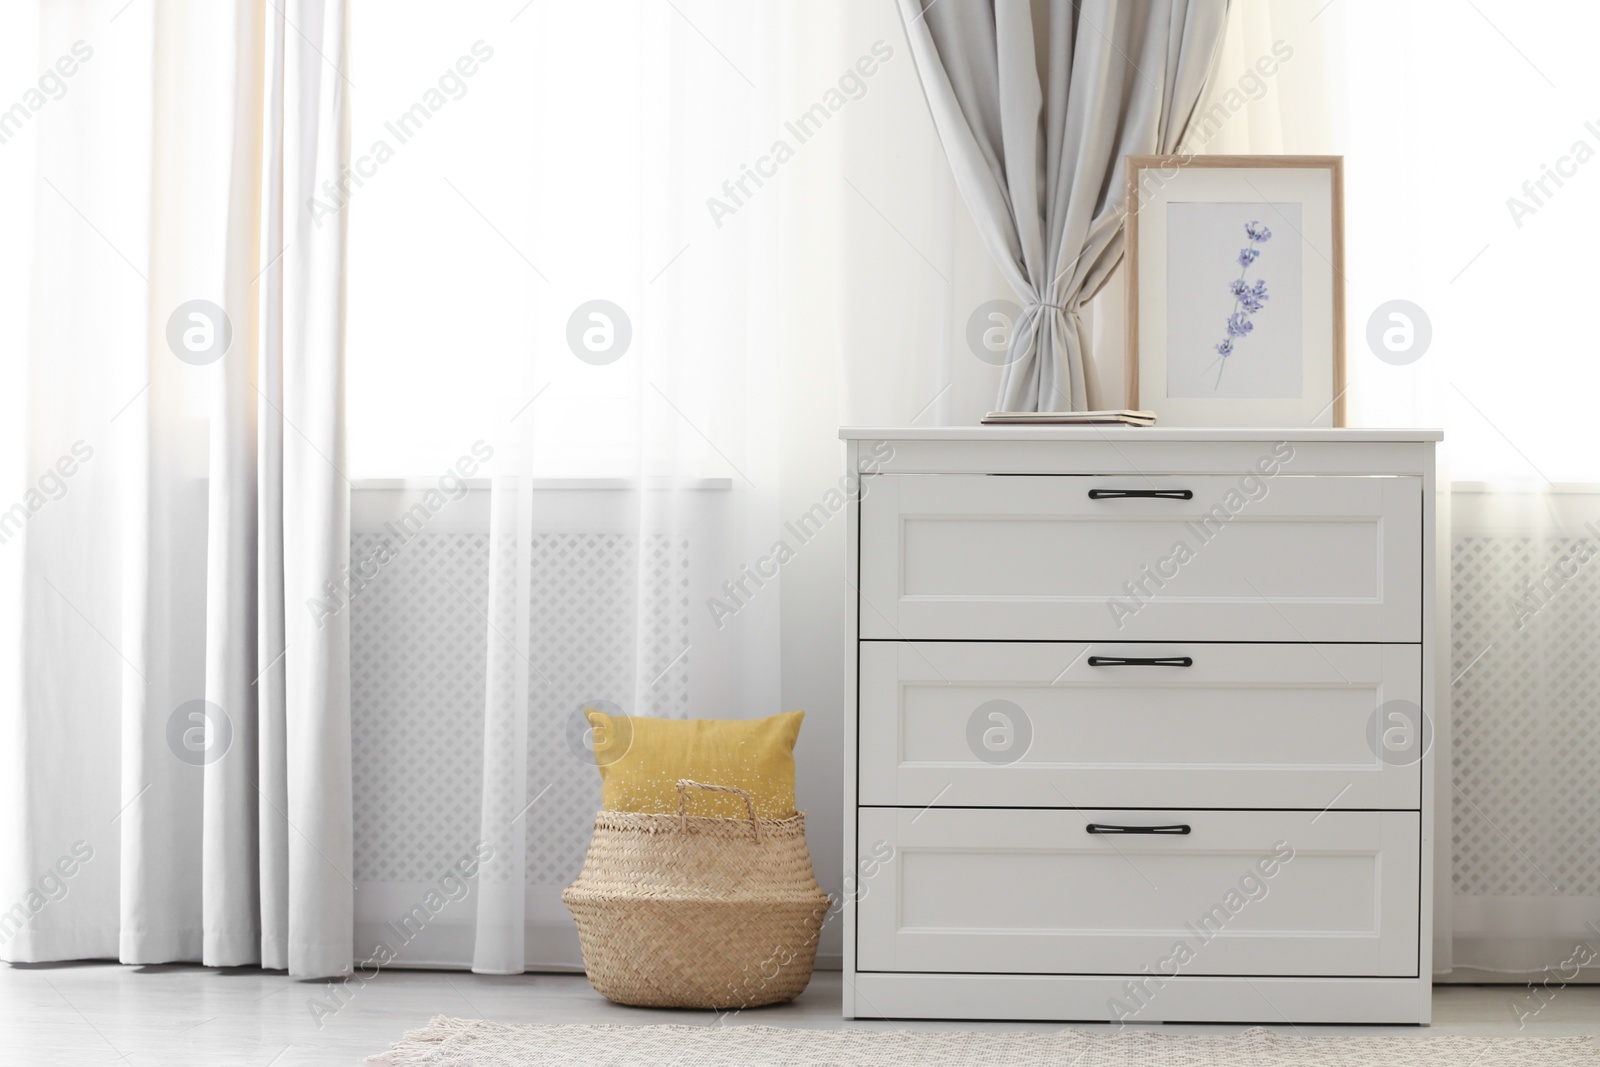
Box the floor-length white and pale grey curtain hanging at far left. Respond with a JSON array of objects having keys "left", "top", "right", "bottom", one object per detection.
[{"left": 0, "top": 0, "right": 354, "bottom": 977}]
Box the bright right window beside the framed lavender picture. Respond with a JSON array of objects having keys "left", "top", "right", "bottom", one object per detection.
[{"left": 1325, "top": 2, "right": 1600, "bottom": 483}]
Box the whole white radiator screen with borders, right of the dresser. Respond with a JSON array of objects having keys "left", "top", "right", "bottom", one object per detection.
[{"left": 1459, "top": 486, "right": 1600, "bottom": 974}]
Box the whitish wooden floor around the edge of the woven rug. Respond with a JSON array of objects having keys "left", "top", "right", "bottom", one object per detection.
[{"left": 0, "top": 963, "right": 1600, "bottom": 1067}]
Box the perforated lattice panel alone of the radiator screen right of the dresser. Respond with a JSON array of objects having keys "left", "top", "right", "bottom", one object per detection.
[{"left": 1451, "top": 536, "right": 1600, "bottom": 918}]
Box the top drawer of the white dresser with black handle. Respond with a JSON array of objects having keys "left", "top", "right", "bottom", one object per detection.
[{"left": 861, "top": 474, "right": 1422, "bottom": 641}]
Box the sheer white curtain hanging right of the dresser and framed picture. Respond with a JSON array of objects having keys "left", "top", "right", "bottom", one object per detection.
[{"left": 1158, "top": 2, "right": 1600, "bottom": 985}]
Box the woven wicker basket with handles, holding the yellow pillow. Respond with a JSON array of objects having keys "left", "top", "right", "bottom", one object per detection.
[{"left": 562, "top": 779, "right": 830, "bottom": 1009}]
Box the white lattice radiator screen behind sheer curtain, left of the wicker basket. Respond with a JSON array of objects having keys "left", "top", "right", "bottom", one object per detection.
[{"left": 350, "top": 489, "right": 693, "bottom": 966}]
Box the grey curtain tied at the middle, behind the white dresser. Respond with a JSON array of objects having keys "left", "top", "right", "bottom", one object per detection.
[{"left": 899, "top": 0, "right": 1227, "bottom": 411}]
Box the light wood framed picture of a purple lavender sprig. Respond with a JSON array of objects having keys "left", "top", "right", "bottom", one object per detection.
[{"left": 1125, "top": 155, "right": 1344, "bottom": 426}]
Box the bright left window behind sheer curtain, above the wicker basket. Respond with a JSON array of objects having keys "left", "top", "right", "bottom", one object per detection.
[{"left": 347, "top": 0, "right": 776, "bottom": 477}]
